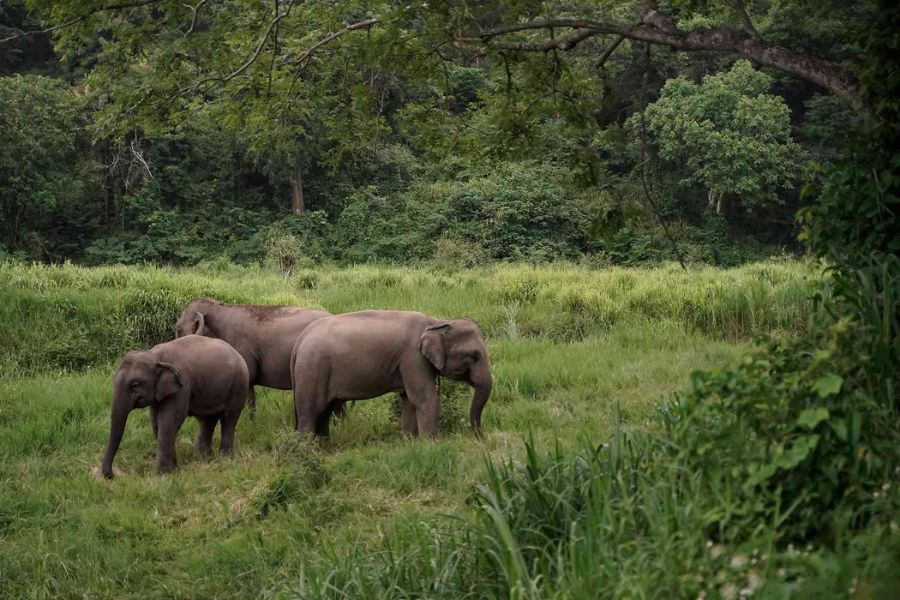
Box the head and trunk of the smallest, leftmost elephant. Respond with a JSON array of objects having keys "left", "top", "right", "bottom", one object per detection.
[{"left": 102, "top": 352, "right": 183, "bottom": 479}]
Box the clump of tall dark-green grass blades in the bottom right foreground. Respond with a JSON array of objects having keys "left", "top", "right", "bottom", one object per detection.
[{"left": 288, "top": 433, "right": 900, "bottom": 599}]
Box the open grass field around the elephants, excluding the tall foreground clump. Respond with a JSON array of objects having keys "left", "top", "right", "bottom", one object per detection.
[{"left": 0, "top": 262, "right": 848, "bottom": 598}]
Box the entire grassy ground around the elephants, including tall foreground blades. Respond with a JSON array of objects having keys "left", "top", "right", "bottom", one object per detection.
[{"left": 7, "top": 262, "right": 884, "bottom": 599}]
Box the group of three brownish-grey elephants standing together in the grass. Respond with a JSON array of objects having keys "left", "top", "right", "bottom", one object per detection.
[{"left": 101, "top": 298, "right": 493, "bottom": 478}]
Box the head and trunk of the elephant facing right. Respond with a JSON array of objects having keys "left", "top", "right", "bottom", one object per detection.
[{"left": 419, "top": 319, "right": 494, "bottom": 434}]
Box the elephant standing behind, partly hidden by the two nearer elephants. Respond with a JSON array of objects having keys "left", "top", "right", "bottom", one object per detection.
[{"left": 175, "top": 298, "right": 331, "bottom": 415}]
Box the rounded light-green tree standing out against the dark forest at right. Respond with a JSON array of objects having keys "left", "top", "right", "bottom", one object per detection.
[{"left": 646, "top": 60, "right": 803, "bottom": 214}]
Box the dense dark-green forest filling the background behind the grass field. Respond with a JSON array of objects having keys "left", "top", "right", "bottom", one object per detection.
[{"left": 0, "top": 0, "right": 864, "bottom": 265}]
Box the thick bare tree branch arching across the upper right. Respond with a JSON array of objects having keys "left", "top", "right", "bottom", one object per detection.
[{"left": 481, "top": 6, "right": 859, "bottom": 101}]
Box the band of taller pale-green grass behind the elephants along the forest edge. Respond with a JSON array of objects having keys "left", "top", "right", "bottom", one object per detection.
[{"left": 0, "top": 261, "right": 820, "bottom": 375}]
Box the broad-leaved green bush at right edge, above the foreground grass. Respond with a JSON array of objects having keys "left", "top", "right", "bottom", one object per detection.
[{"left": 665, "top": 320, "right": 900, "bottom": 543}]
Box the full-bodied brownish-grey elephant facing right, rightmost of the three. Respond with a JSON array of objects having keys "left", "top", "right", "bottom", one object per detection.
[{"left": 291, "top": 310, "right": 493, "bottom": 437}]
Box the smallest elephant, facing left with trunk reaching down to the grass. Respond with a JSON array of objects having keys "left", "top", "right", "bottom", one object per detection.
[{"left": 102, "top": 335, "right": 250, "bottom": 479}]
